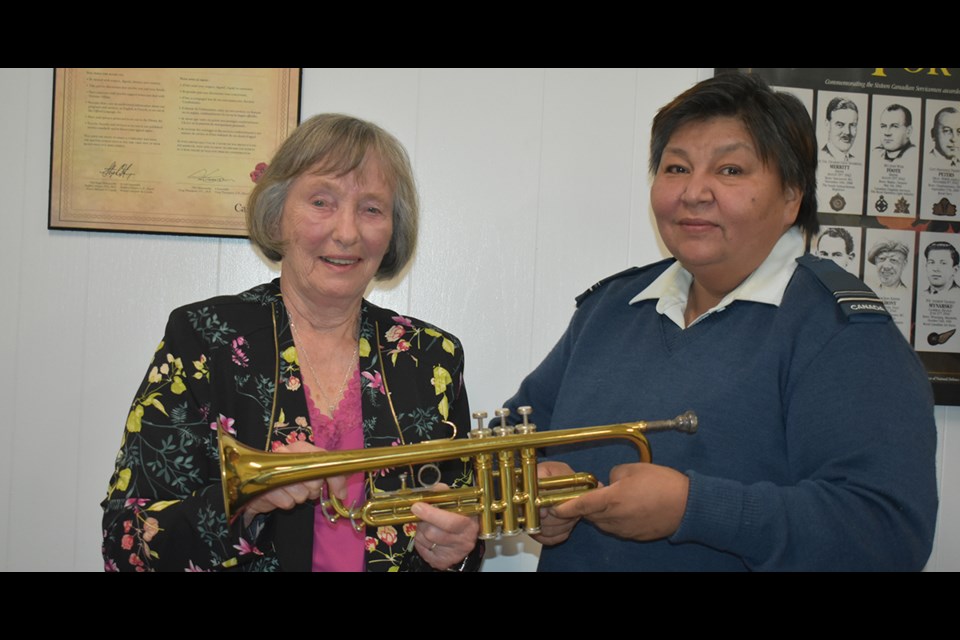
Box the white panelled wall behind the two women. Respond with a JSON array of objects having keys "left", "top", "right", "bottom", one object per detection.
[{"left": 0, "top": 69, "right": 960, "bottom": 571}]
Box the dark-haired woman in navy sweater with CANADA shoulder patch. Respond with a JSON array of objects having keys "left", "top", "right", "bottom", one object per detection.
[{"left": 507, "top": 74, "right": 937, "bottom": 571}]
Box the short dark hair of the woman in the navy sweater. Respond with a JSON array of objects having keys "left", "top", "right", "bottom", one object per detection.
[{"left": 650, "top": 72, "right": 820, "bottom": 237}]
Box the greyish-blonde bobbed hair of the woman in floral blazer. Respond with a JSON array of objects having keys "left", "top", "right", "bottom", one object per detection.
[{"left": 247, "top": 113, "right": 420, "bottom": 279}]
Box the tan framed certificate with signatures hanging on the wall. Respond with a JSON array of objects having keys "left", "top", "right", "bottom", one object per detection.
[{"left": 48, "top": 68, "right": 300, "bottom": 236}]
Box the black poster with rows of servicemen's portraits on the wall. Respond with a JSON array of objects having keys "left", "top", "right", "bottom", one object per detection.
[{"left": 716, "top": 68, "right": 960, "bottom": 405}]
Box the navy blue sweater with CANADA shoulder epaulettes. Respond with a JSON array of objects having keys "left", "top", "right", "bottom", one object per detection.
[{"left": 506, "top": 263, "right": 937, "bottom": 571}]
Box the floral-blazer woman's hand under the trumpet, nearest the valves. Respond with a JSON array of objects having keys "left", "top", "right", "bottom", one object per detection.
[{"left": 410, "top": 484, "right": 480, "bottom": 571}]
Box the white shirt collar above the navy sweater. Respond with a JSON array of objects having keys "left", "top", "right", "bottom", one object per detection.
[{"left": 630, "top": 227, "right": 803, "bottom": 329}]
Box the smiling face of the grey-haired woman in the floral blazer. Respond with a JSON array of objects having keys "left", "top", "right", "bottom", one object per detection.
[{"left": 280, "top": 155, "right": 393, "bottom": 304}]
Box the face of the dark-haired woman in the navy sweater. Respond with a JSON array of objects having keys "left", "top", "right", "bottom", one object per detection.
[{"left": 651, "top": 117, "right": 800, "bottom": 292}]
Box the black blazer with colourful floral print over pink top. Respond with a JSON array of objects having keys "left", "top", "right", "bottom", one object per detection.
[{"left": 101, "top": 280, "right": 472, "bottom": 571}]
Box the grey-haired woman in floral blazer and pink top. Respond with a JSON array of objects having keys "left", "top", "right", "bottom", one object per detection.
[{"left": 102, "top": 115, "right": 483, "bottom": 571}]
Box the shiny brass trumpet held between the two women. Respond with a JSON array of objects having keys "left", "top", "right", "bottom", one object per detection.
[{"left": 218, "top": 407, "right": 697, "bottom": 539}]
